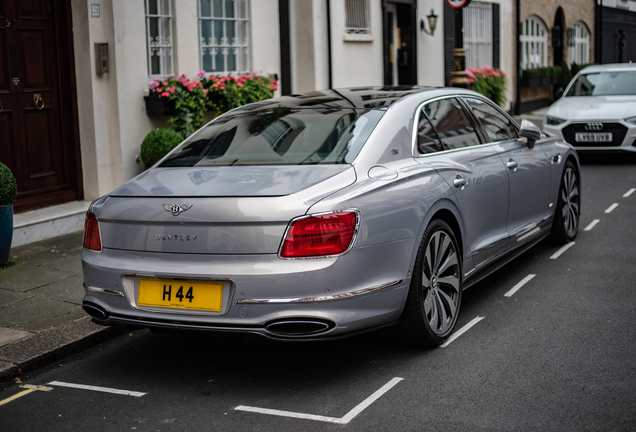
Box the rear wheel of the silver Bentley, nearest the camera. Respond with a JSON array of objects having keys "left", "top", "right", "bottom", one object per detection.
[{"left": 398, "top": 219, "right": 462, "bottom": 347}]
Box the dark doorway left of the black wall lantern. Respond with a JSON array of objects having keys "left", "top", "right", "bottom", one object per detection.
[{"left": 383, "top": 0, "right": 417, "bottom": 85}]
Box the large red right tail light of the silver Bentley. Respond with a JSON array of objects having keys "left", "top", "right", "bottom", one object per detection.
[{"left": 280, "top": 211, "right": 358, "bottom": 258}]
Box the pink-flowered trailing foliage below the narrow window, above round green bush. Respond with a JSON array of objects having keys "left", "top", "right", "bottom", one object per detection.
[{"left": 150, "top": 75, "right": 209, "bottom": 138}]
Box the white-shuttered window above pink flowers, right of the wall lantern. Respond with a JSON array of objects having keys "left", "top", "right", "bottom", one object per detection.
[{"left": 463, "top": 2, "right": 493, "bottom": 69}]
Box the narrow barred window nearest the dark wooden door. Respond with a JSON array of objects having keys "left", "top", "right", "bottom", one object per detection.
[{"left": 145, "top": 0, "right": 174, "bottom": 80}]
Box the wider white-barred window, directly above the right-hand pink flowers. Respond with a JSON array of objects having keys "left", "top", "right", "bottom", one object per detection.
[{"left": 199, "top": 0, "right": 250, "bottom": 73}]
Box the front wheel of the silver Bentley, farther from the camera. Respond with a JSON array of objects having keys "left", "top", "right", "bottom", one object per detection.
[{"left": 551, "top": 161, "right": 581, "bottom": 243}]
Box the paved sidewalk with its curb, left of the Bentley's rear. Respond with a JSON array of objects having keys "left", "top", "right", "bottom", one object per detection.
[{"left": 0, "top": 232, "right": 124, "bottom": 382}]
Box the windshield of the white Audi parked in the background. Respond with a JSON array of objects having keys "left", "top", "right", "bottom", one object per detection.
[{"left": 566, "top": 71, "right": 636, "bottom": 96}]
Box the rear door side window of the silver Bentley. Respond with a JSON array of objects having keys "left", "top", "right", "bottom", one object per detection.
[{"left": 423, "top": 98, "right": 479, "bottom": 149}]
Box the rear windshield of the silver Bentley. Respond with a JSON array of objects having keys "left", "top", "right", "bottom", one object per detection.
[{"left": 160, "top": 107, "right": 384, "bottom": 167}]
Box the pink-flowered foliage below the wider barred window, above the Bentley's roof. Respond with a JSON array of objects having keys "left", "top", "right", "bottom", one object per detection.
[{"left": 199, "top": 72, "right": 278, "bottom": 114}]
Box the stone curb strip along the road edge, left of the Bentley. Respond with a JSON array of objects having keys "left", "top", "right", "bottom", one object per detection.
[{"left": 0, "top": 317, "right": 129, "bottom": 381}]
